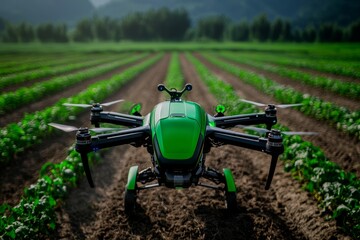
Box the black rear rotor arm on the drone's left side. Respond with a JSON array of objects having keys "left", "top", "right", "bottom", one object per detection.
[{"left": 90, "top": 112, "right": 143, "bottom": 127}]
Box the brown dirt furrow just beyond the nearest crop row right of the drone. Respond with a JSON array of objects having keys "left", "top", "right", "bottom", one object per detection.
[{"left": 198, "top": 56, "right": 360, "bottom": 177}]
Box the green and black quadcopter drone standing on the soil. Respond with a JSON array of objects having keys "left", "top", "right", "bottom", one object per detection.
[{"left": 52, "top": 84, "right": 314, "bottom": 214}]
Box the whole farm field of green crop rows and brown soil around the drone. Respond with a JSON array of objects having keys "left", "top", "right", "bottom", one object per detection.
[{"left": 0, "top": 43, "right": 360, "bottom": 239}]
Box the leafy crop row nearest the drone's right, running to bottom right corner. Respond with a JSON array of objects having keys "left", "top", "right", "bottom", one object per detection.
[{"left": 187, "top": 54, "right": 360, "bottom": 239}]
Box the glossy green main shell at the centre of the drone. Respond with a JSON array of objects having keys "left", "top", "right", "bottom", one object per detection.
[{"left": 150, "top": 101, "right": 207, "bottom": 160}]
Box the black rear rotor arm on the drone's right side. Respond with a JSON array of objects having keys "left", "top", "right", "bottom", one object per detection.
[{"left": 213, "top": 113, "right": 277, "bottom": 129}]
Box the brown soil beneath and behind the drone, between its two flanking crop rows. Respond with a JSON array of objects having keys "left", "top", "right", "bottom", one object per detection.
[{"left": 54, "top": 56, "right": 349, "bottom": 239}]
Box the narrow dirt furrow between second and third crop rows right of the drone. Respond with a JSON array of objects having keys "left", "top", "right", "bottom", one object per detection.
[{"left": 218, "top": 54, "right": 360, "bottom": 111}]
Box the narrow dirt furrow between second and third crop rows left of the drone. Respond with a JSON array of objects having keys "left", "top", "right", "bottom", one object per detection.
[{"left": 0, "top": 56, "right": 148, "bottom": 127}]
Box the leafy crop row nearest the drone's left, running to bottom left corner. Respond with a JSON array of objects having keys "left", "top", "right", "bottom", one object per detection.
[{"left": 0, "top": 55, "right": 162, "bottom": 239}]
